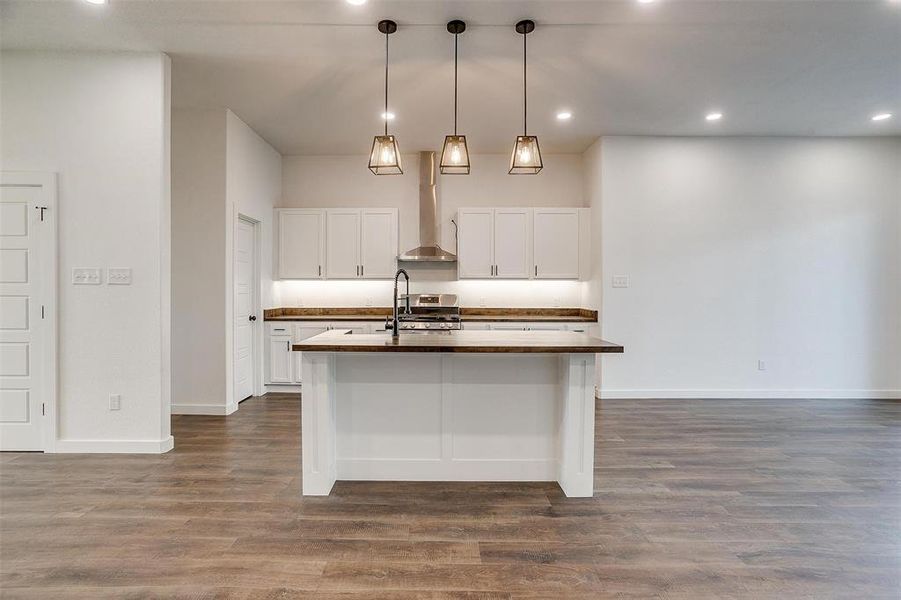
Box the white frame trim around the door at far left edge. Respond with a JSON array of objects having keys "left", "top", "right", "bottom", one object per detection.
[{"left": 0, "top": 171, "right": 59, "bottom": 452}]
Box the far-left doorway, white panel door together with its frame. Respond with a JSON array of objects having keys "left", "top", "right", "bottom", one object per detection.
[{"left": 0, "top": 172, "right": 57, "bottom": 451}]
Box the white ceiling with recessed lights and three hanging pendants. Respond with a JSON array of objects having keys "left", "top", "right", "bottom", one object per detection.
[{"left": 0, "top": 0, "right": 901, "bottom": 154}]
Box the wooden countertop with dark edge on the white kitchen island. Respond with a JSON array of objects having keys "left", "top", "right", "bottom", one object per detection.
[{"left": 291, "top": 329, "right": 623, "bottom": 354}]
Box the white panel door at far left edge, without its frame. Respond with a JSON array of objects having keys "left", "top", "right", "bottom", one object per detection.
[{"left": 0, "top": 184, "right": 50, "bottom": 450}]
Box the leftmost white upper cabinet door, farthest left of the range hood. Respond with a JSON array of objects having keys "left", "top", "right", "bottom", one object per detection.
[{"left": 278, "top": 208, "right": 325, "bottom": 279}]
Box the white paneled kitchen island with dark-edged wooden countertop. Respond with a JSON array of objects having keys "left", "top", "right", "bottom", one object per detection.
[{"left": 292, "top": 330, "right": 623, "bottom": 496}]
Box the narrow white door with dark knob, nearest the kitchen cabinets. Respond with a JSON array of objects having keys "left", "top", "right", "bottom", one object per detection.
[{"left": 234, "top": 218, "right": 257, "bottom": 402}]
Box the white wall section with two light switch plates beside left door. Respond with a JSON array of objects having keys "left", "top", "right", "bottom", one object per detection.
[{"left": 0, "top": 52, "right": 172, "bottom": 452}]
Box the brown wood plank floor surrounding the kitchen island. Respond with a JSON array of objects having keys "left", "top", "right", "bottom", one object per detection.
[{"left": 0, "top": 396, "right": 901, "bottom": 600}]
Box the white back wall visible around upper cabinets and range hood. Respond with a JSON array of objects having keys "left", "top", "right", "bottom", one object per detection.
[{"left": 280, "top": 154, "right": 585, "bottom": 307}]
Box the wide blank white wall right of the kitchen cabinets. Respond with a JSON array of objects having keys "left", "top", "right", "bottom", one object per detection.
[{"left": 587, "top": 138, "right": 901, "bottom": 398}]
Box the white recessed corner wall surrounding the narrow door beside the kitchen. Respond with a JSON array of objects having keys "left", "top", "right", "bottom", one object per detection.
[{"left": 172, "top": 108, "right": 282, "bottom": 414}]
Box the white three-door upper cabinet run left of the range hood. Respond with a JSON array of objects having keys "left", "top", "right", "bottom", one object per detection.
[{"left": 276, "top": 208, "right": 398, "bottom": 279}]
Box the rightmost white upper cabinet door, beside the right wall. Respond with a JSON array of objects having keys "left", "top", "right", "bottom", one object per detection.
[{"left": 532, "top": 208, "right": 579, "bottom": 279}]
